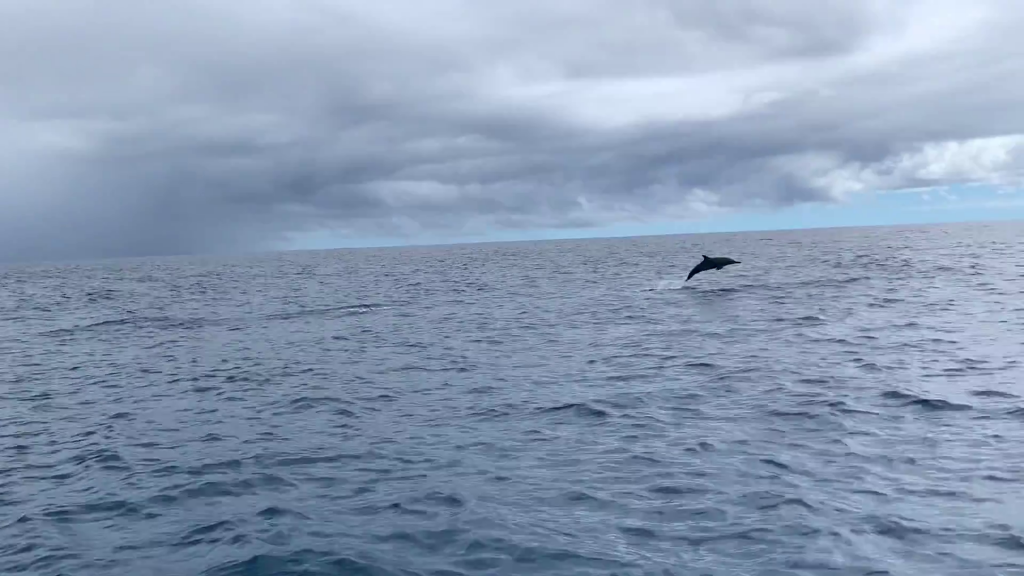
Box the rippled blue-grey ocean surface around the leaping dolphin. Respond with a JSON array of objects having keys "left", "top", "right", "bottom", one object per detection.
[{"left": 0, "top": 222, "right": 1024, "bottom": 576}]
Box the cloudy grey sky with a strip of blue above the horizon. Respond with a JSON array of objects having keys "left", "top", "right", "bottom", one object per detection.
[{"left": 0, "top": 0, "right": 1024, "bottom": 261}]
